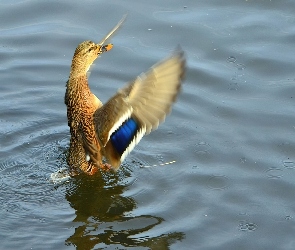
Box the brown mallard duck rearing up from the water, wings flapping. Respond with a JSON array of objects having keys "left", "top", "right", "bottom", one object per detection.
[{"left": 65, "top": 19, "right": 185, "bottom": 175}]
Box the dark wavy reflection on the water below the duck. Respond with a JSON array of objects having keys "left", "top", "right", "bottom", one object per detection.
[{"left": 66, "top": 168, "right": 184, "bottom": 249}]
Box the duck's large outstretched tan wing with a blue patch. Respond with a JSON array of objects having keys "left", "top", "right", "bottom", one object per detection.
[{"left": 94, "top": 49, "right": 185, "bottom": 169}]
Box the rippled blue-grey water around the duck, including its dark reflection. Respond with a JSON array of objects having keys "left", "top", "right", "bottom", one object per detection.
[{"left": 0, "top": 0, "right": 295, "bottom": 249}]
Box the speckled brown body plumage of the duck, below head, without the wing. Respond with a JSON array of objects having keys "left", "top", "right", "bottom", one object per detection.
[{"left": 65, "top": 73, "right": 102, "bottom": 173}]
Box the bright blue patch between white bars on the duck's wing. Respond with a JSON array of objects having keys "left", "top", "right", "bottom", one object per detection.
[{"left": 111, "top": 118, "right": 138, "bottom": 155}]
